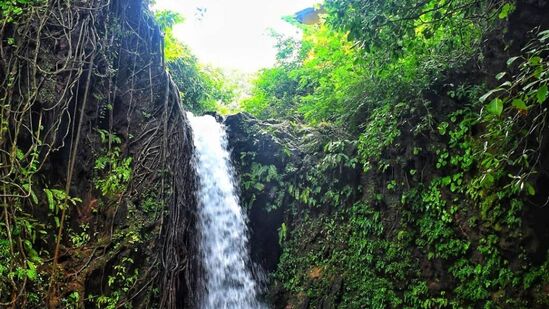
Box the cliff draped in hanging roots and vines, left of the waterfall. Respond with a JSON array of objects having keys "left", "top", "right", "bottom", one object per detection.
[{"left": 0, "top": 0, "right": 198, "bottom": 308}]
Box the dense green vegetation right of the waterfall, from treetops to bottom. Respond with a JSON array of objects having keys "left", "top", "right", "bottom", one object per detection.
[{"left": 231, "top": 0, "right": 549, "bottom": 308}]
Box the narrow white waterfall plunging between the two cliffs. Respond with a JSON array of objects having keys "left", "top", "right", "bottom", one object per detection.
[{"left": 188, "top": 113, "right": 265, "bottom": 309}]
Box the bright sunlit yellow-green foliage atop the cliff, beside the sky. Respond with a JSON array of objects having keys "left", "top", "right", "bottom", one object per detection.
[{"left": 241, "top": 25, "right": 365, "bottom": 123}]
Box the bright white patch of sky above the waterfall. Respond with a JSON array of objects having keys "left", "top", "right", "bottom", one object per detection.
[{"left": 154, "top": 0, "right": 319, "bottom": 73}]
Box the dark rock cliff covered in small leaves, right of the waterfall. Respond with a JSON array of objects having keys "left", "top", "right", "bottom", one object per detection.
[{"left": 225, "top": 1, "right": 549, "bottom": 308}]
